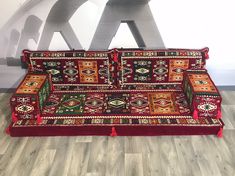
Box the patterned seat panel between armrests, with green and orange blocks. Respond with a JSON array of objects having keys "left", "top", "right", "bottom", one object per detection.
[{"left": 42, "top": 90, "right": 192, "bottom": 118}]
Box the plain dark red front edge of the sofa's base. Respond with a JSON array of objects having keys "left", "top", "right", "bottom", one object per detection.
[{"left": 8, "top": 121, "right": 223, "bottom": 137}]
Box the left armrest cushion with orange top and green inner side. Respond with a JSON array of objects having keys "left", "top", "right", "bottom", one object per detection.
[{"left": 10, "top": 73, "right": 50, "bottom": 121}]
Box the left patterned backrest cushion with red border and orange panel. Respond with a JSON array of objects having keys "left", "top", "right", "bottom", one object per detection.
[{"left": 24, "top": 51, "right": 117, "bottom": 90}]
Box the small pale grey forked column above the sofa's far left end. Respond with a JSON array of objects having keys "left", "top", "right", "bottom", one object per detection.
[{"left": 15, "top": 15, "right": 42, "bottom": 58}]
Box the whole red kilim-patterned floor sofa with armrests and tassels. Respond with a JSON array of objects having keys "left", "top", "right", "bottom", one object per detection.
[{"left": 7, "top": 48, "right": 224, "bottom": 137}]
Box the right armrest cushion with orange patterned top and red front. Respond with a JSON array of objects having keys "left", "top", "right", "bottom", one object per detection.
[{"left": 183, "top": 70, "right": 222, "bottom": 118}]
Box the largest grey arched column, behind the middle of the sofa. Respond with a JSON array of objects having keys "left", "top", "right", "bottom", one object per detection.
[{"left": 90, "top": 0, "right": 164, "bottom": 50}]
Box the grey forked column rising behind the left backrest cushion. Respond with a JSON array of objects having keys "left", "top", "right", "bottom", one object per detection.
[{"left": 38, "top": 0, "right": 87, "bottom": 50}]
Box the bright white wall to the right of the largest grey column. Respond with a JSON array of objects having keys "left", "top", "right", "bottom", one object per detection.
[{"left": 150, "top": 0, "right": 235, "bottom": 69}]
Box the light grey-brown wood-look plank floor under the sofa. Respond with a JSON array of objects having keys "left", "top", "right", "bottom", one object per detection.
[{"left": 0, "top": 91, "right": 235, "bottom": 176}]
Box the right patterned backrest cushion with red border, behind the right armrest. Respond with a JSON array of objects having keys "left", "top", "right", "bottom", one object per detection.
[{"left": 118, "top": 48, "right": 208, "bottom": 89}]
